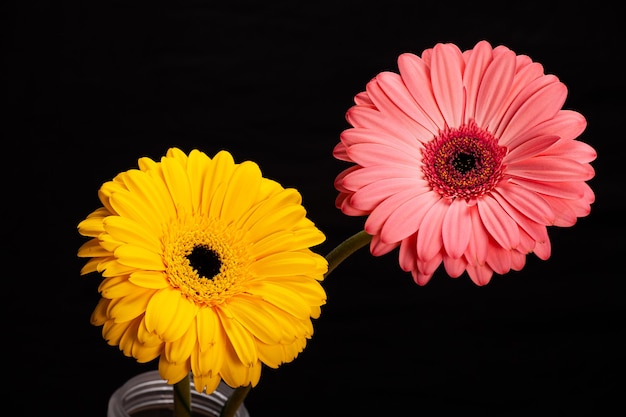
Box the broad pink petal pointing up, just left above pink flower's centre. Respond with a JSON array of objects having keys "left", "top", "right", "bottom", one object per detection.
[{"left": 431, "top": 43, "right": 465, "bottom": 127}]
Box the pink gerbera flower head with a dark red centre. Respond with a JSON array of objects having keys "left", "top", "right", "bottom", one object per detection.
[{"left": 334, "top": 41, "right": 596, "bottom": 285}]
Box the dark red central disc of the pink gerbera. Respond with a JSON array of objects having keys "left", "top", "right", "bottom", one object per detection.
[{"left": 422, "top": 122, "right": 507, "bottom": 199}]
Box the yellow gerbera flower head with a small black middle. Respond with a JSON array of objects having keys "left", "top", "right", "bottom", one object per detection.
[{"left": 78, "top": 148, "right": 328, "bottom": 392}]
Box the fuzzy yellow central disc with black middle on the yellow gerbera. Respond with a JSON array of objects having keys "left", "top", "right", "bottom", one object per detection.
[{"left": 163, "top": 216, "right": 251, "bottom": 307}]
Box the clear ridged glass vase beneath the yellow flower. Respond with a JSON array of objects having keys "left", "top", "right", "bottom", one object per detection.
[{"left": 107, "top": 371, "right": 250, "bottom": 417}]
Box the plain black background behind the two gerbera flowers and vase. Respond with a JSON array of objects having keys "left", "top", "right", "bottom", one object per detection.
[{"left": 2, "top": 0, "right": 626, "bottom": 417}]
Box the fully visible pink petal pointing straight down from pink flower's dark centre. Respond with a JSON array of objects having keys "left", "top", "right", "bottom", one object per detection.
[{"left": 441, "top": 198, "right": 472, "bottom": 258}]
